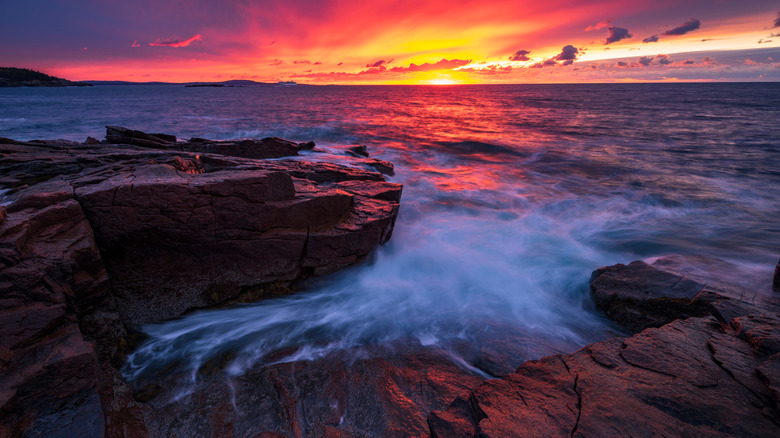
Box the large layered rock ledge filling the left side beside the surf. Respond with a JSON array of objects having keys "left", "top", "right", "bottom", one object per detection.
[{"left": 0, "top": 128, "right": 401, "bottom": 437}]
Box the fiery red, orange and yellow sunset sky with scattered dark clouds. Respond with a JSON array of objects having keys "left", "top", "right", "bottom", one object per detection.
[{"left": 0, "top": 0, "right": 780, "bottom": 84}]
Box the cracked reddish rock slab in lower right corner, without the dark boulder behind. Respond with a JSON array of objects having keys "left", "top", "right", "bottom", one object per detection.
[{"left": 428, "top": 318, "right": 780, "bottom": 437}]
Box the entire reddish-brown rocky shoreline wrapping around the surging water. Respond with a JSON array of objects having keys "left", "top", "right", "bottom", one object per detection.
[{"left": 0, "top": 127, "right": 780, "bottom": 437}]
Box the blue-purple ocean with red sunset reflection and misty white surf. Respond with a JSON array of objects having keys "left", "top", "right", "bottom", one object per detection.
[{"left": 0, "top": 83, "right": 780, "bottom": 388}]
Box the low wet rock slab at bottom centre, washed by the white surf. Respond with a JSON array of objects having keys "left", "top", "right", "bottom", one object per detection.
[{"left": 137, "top": 344, "right": 482, "bottom": 437}]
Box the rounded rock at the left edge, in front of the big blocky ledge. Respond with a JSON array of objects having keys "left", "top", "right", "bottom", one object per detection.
[{"left": 0, "top": 192, "right": 131, "bottom": 437}]
